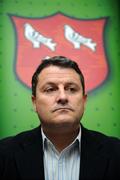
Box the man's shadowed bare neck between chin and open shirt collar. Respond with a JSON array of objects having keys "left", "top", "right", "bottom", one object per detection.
[{"left": 43, "top": 126, "right": 80, "bottom": 152}]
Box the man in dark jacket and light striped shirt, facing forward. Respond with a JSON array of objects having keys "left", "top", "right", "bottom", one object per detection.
[{"left": 0, "top": 56, "right": 120, "bottom": 180}]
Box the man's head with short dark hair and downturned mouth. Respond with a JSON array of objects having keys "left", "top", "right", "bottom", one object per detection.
[{"left": 32, "top": 56, "right": 86, "bottom": 133}]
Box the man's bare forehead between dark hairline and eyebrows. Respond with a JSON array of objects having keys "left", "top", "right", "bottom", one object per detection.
[{"left": 38, "top": 66, "right": 80, "bottom": 84}]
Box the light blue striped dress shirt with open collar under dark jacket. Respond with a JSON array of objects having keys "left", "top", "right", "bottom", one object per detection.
[{"left": 41, "top": 128, "right": 81, "bottom": 180}]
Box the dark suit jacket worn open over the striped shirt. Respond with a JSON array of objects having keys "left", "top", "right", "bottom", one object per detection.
[{"left": 0, "top": 126, "right": 120, "bottom": 180}]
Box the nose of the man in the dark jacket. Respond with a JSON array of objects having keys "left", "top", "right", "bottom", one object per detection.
[{"left": 57, "top": 89, "right": 68, "bottom": 105}]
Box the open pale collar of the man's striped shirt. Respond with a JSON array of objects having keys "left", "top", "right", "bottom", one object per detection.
[{"left": 41, "top": 125, "right": 81, "bottom": 151}]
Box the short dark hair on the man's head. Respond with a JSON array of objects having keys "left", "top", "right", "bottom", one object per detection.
[{"left": 32, "top": 56, "right": 85, "bottom": 96}]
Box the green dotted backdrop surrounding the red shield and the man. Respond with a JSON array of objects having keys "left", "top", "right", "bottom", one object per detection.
[{"left": 0, "top": 0, "right": 120, "bottom": 138}]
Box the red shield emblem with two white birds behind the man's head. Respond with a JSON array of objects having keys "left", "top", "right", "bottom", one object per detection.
[{"left": 11, "top": 13, "right": 108, "bottom": 92}]
